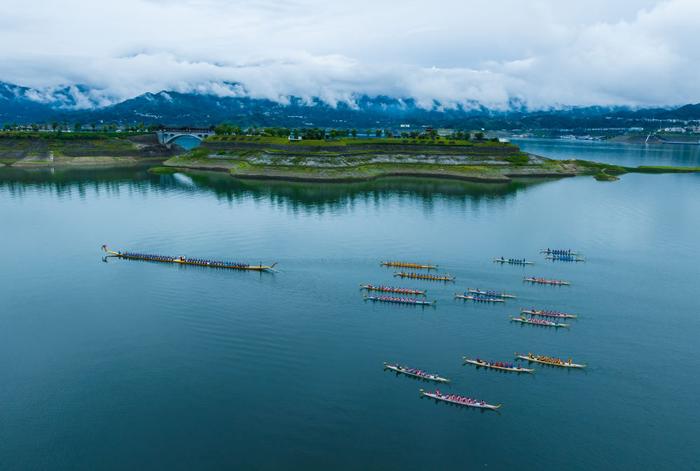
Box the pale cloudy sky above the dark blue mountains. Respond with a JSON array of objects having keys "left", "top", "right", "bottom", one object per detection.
[{"left": 0, "top": 0, "right": 700, "bottom": 108}]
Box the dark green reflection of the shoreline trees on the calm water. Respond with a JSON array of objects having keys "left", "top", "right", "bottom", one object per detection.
[{"left": 0, "top": 167, "right": 548, "bottom": 211}]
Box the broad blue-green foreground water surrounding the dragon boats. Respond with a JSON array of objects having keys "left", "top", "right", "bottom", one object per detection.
[{"left": 0, "top": 158, "right": 700, "bottom": 470}]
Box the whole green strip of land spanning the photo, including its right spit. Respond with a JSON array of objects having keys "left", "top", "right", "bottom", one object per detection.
[{"left": 0, "top": 132, "right": 700, "bottom": 183}]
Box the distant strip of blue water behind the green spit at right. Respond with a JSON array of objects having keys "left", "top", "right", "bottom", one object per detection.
[{"left": 513, "top": 139, "right": 700, "bottom": 167}]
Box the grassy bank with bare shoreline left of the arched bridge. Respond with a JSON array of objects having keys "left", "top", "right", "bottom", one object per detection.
[{"left": 0, "top": 132, "right": 173, "bottom": 167}]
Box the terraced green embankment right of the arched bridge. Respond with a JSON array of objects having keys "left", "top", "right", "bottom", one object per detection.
[{"left": 163, "top": 136, "right": 577, "bottom": 182}]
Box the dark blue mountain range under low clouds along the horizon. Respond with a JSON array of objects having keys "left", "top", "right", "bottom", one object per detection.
[{"left": 0, "top": 82, "right": 700, "bottom": 129}]
